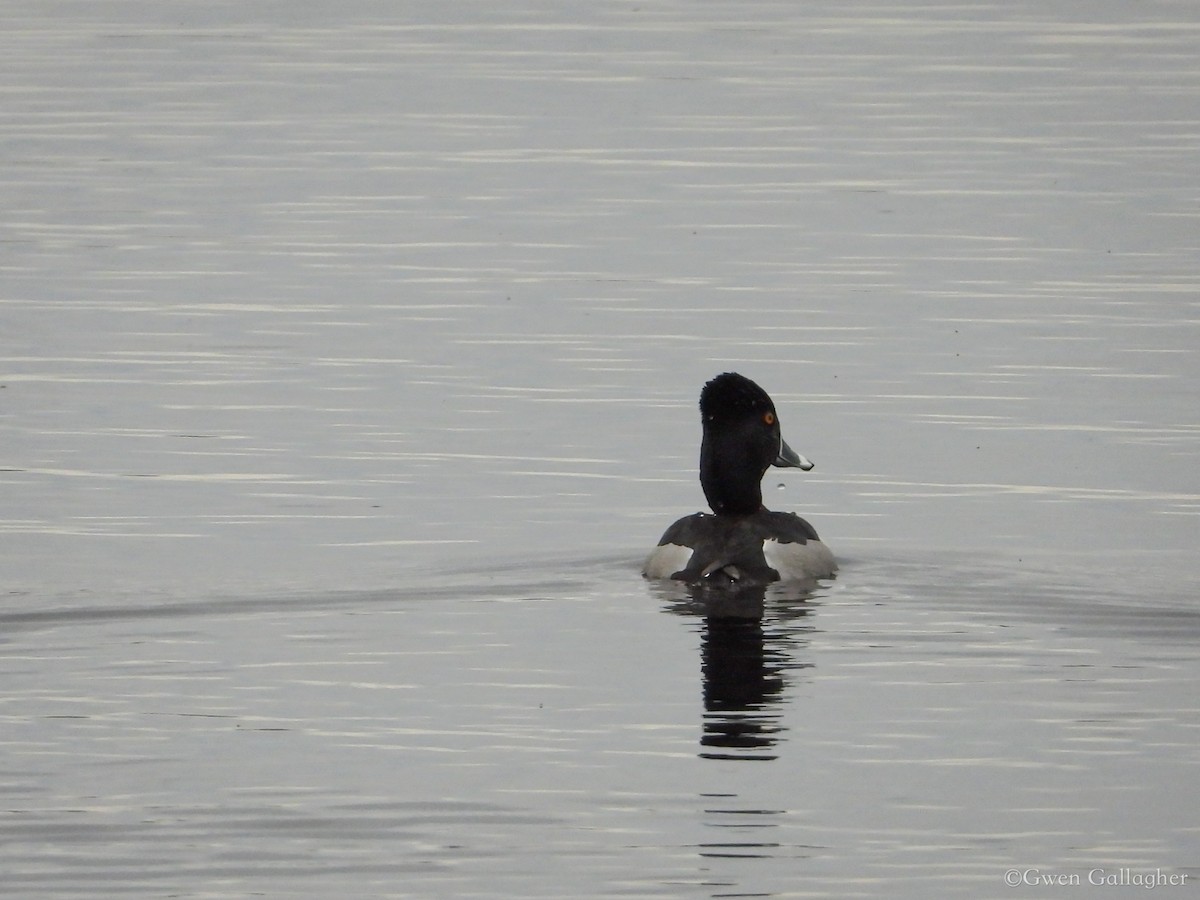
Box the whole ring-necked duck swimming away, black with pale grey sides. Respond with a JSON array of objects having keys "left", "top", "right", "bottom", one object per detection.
[{"left": 642, "top": 372, "right": 838, "bottom": 586}]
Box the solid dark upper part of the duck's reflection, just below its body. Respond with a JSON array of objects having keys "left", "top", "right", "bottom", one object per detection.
[{"left": 666, "top": 584, "right": 814, "bottom": 761}]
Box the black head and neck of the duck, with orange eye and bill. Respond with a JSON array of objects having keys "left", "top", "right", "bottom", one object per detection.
[{"left": 700, "top": 372, "right": 812, "bottom": 516}]
